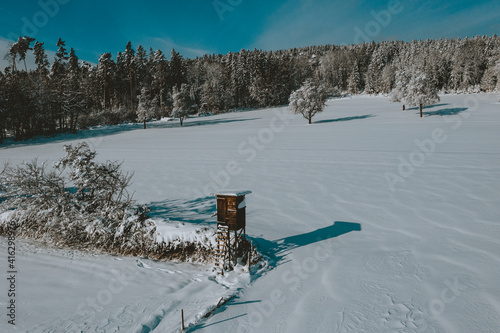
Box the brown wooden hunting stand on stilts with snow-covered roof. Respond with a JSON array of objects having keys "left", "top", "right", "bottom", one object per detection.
[{"left": 215, "top": 190, "right": 252, "bottom": 273}]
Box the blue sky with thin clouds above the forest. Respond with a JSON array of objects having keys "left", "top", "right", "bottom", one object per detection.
[{"left": 0, "top": 0, "right": 500, "bottom": 64}]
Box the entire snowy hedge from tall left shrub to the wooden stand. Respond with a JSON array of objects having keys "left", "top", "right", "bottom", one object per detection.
[{"left": 0, "top": 143, "right": 215, "bottom": 260}]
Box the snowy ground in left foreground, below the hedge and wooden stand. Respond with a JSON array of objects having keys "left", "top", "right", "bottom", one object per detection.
[{"left": 0, "top": 241, "right": 233, "bottom": 332}]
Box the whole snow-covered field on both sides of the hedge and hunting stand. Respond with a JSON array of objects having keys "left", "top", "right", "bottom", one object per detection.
[{"left": 0, "top": 94, "right": 500, "bottom": 333}]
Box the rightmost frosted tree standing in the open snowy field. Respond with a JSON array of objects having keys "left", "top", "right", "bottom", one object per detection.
[{"left": 402, "top": 72, "right": 440, "bottom": 117}]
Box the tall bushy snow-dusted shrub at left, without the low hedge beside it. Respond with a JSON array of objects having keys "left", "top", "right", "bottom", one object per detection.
[{"left": 0, "top": 143, "right": 147, "bottom": 247}]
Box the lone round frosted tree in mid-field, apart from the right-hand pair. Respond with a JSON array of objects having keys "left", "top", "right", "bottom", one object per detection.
[{"left": 289, "top": 79, "right": 327, "bottom": 124}]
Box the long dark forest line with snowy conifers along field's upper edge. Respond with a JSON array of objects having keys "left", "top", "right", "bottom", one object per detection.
[{"left": 0, "top": 35, "right": 500, "bottom": 141}]
